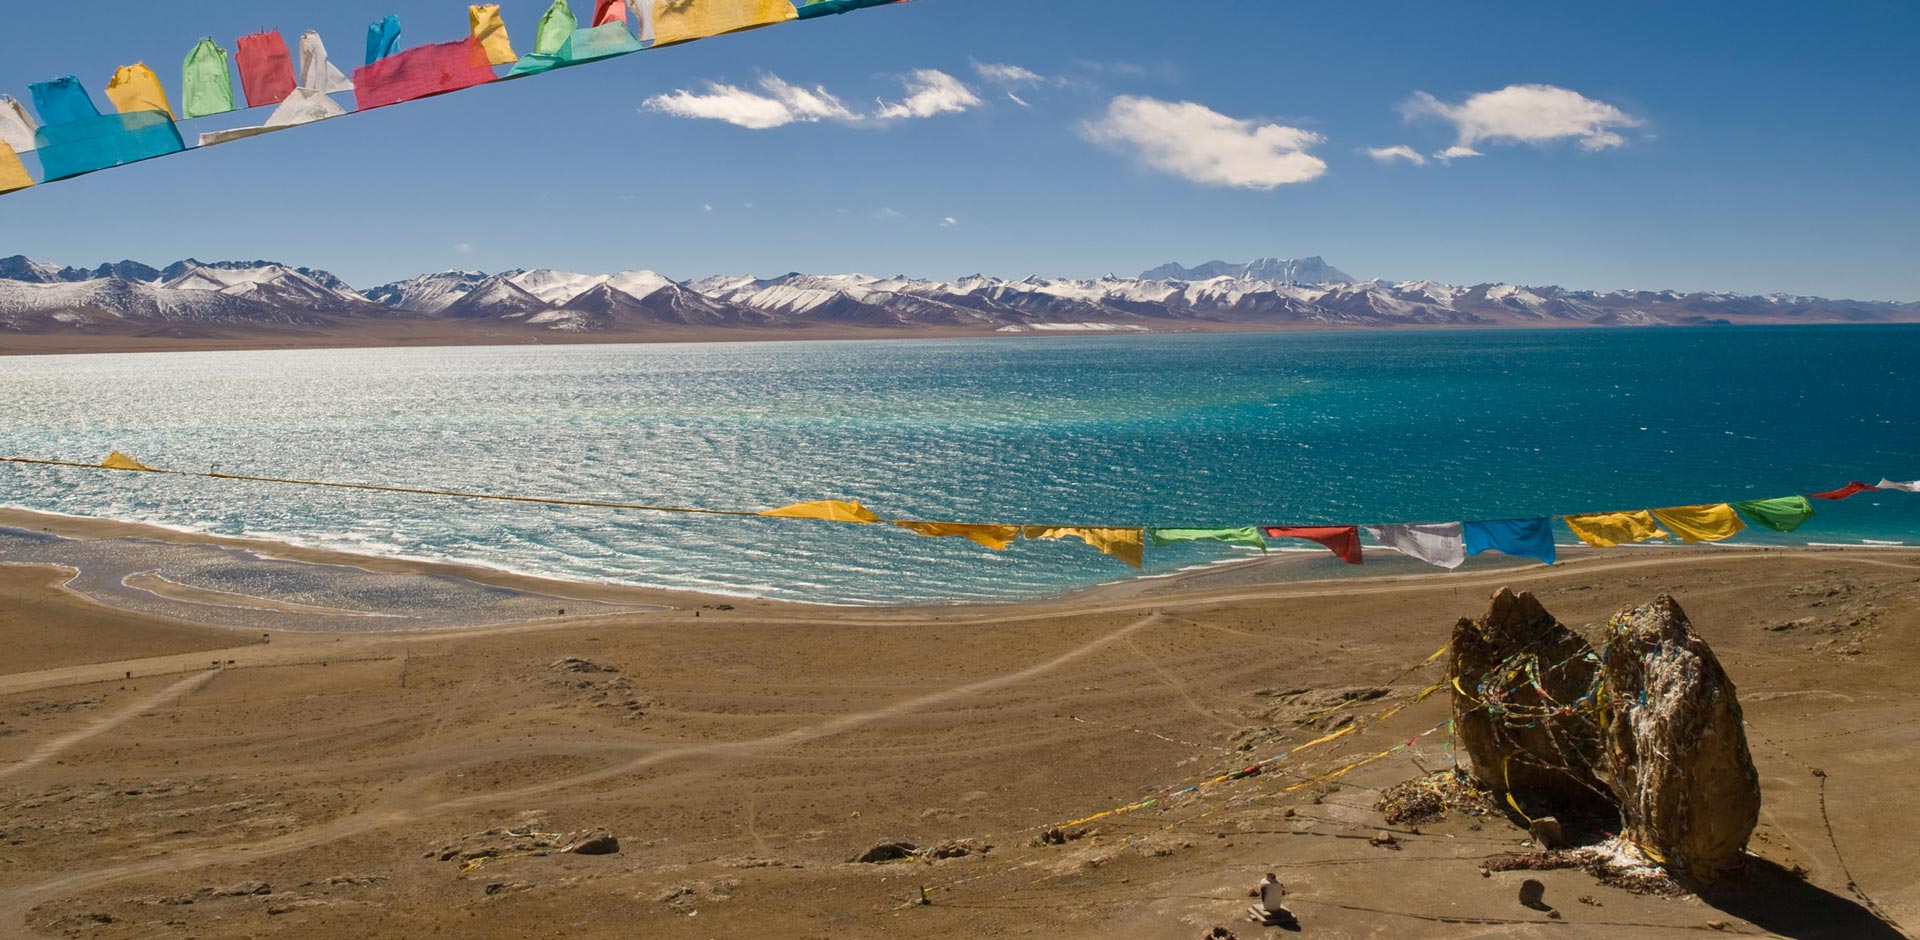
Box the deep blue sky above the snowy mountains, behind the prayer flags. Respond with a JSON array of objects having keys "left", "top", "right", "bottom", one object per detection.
[{"left": 0, "top": 0, "right": 1920, "bottom": 301}]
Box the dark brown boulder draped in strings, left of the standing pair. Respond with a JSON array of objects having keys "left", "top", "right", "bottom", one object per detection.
[{"left": 1448, "top": 587, "right": 1611, "bottom": 815}]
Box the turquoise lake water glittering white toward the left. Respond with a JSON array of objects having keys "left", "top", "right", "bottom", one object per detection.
[{"left": 0, "top": 326, "right": 1920, "bottom": 602}]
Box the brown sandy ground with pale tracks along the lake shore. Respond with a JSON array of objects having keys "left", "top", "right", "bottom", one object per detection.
[{"left": 0, "top": 524, "right": 1920, "bottom": 940}]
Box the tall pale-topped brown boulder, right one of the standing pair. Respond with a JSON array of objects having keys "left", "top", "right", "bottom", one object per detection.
[{"left": 1603, "top": 595, "right": 1761, "bottom": 884}]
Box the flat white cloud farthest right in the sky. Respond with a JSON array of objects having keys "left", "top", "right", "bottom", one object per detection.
[{"left": 1400, "top": 84, "right": 1642, "bottom": 152}]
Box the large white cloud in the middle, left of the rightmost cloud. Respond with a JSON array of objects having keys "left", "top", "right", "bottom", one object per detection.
[{"left": 1081, "top": 96, "right": 1327, "bottom": 190}]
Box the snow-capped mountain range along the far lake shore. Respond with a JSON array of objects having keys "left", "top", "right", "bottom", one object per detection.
[{"left": 0, "top": 257, "right": 1920, "bottom": 351}]
